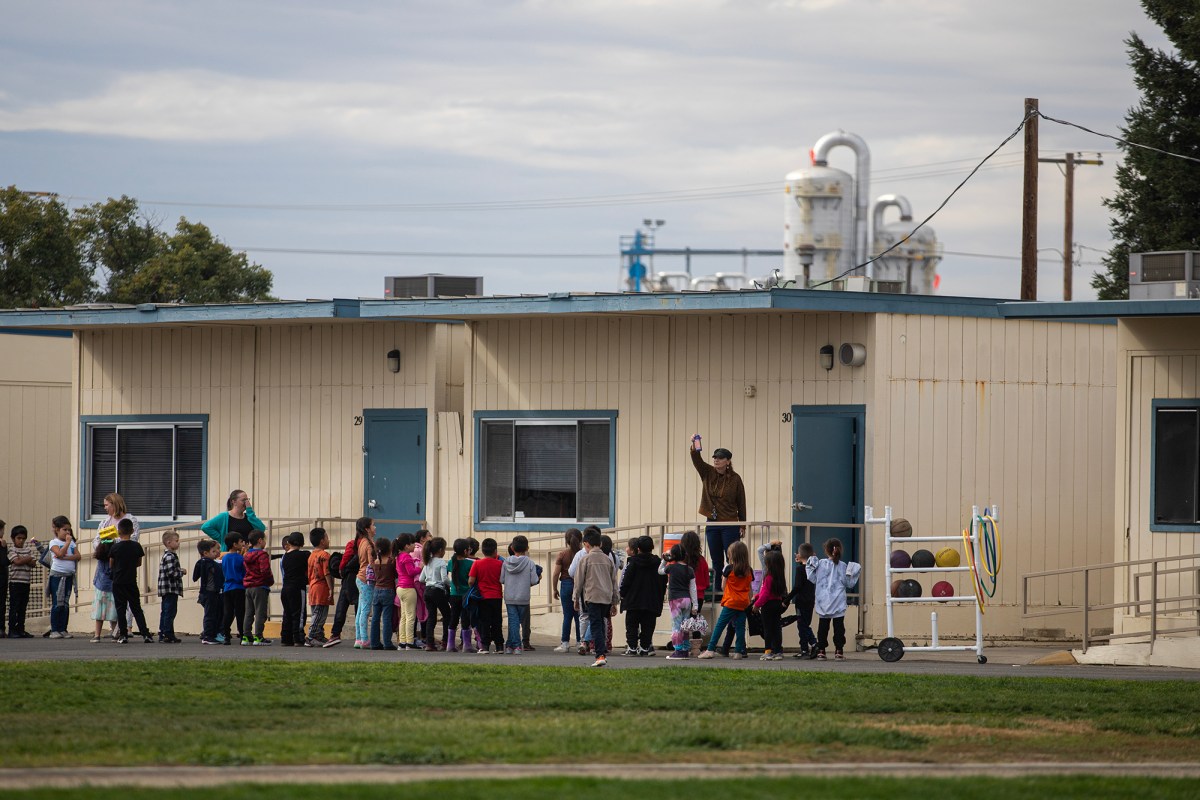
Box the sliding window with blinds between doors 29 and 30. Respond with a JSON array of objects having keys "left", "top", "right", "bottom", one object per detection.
[{"left": 479, "top": 419, "right": 612, "bottom": 522}]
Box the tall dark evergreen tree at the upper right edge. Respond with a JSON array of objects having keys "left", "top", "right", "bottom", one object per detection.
[{"left": 1092, "top": 0, "right": 1200, "bottom": 300}]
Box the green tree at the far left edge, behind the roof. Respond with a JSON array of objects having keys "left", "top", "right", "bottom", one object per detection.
[{"left": 0, "top": 186, "right": 96, "bottom": 308}]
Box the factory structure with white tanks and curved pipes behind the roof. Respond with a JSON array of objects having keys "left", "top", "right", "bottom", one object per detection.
[{"left": 620, "top": 131, "right": 942, "bottom": 295}]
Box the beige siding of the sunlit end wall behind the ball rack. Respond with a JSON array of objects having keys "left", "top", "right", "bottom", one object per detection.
[{"left": 866, "top": 314, "right": 1116, "bottom": 637}]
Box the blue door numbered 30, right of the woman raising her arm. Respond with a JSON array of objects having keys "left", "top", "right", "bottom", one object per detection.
[{"left": 792, "top": 405, "right": 865, "bottom": 563}]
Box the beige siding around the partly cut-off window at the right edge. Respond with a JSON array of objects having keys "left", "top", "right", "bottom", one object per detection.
[{"left": 1114, "top": 319, "right": 1200, "bottom": 632}]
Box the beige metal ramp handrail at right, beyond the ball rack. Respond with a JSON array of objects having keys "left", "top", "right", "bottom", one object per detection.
[{"left": 1021, "top": 553, "right": 1200, "bottom": 654}]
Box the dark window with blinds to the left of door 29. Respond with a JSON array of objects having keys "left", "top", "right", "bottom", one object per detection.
[{"left": 86, "top": 423, "right": 204, "bottom": 521}]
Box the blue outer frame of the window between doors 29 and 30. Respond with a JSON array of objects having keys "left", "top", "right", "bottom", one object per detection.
[{"left": 472, "top": 410, "right": 618, "bottom": 531}]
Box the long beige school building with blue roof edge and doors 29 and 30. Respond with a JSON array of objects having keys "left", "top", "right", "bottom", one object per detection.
[{"left": 0, "top": 289, "right": 1124, "bottom": 644}]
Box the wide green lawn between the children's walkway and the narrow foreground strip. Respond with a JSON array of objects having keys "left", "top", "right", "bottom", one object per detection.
[{"left": 0, "top": 660, "right": 1200, "bottom": 767}]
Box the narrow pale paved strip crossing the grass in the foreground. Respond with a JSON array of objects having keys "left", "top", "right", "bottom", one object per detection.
[{"left": 7, "top": 762, "right": 1200, "bottom": 789}]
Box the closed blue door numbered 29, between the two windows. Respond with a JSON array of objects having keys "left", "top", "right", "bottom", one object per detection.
[{"left": 362, "top": 409, "right": 427, "bottom": 539}]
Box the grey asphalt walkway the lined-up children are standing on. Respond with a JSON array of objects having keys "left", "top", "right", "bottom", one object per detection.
[{"left": 0, "top": 634, "right": 1200, "bottom": 681}]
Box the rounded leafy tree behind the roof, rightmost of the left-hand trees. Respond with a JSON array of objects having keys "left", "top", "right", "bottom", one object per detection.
[{"left": 108, "top": 217, "right": 274, "bottom": 303}]
